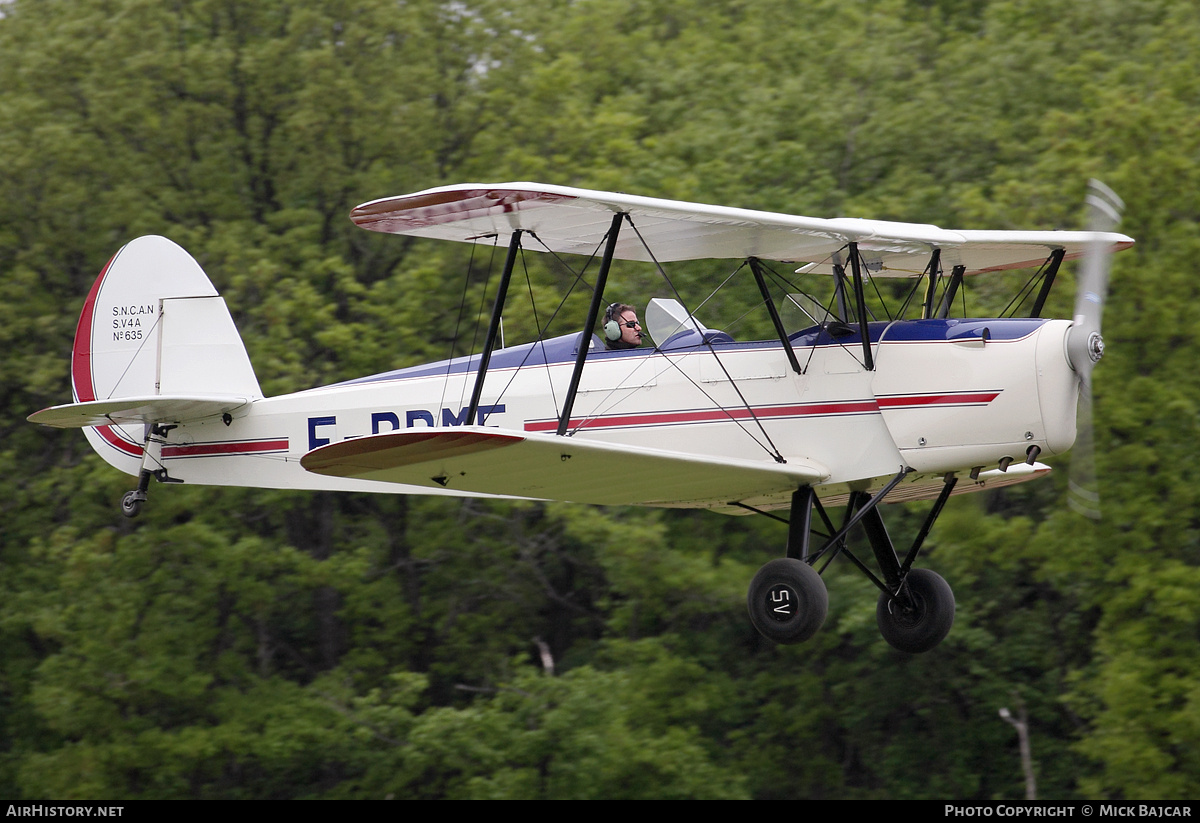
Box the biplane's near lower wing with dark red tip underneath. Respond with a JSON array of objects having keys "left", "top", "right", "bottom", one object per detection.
[{"left": 300, "top": 426, "right": 828, "bottom": 507}]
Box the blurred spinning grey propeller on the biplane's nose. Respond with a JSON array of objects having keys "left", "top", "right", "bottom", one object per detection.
[{"left": 1067, "top": 180, "right": 1124, "bottom": 519}]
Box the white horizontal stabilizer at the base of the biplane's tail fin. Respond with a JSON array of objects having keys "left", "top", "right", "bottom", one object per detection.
[{"left": 28, "top": 395, "right": 251, "bottom": 428}]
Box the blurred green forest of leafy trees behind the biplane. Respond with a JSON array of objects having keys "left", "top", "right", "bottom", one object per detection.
[{"left": 0, "top": 0, "right": 1200, "bottom": 800}]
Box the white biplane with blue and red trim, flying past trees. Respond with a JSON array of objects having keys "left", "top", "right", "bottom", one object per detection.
[{"left": 29, "top": 184, "right": 1133, "bottom": 653}]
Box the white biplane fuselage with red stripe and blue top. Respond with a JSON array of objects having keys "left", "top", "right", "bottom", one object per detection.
[{"left": 88, "top": 319, "right": 1078, "bottom": 511}]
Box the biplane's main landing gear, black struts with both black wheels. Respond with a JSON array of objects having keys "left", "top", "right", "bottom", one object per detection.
[{"left": 746, "top": 469, "right": 958, "bottom": 654}]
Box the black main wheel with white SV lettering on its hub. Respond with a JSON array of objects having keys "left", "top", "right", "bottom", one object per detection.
[{"left": 746, "top": 558, "right": 829, "bottom": 643}]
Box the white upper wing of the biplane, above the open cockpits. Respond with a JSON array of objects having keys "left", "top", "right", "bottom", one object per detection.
[{"left": 350, "top": 182, "right": 1133, "bottom": 277}]
